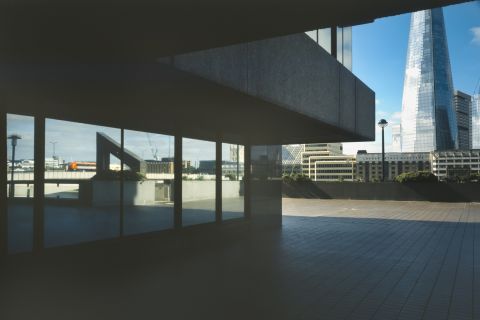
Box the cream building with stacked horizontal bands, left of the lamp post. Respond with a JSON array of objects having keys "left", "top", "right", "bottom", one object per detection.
[{"left": 301, "top": 143, "right": 355, "bottom": 181}]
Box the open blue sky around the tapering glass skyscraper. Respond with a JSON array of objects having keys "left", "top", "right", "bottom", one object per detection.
[{"left": 344, "top": 1, "right": 480, "bottom": 154}]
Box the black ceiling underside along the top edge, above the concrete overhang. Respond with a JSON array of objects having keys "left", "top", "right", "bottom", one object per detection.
[{"left": 0, "top": 0, "right": 465, "bottom": 62}]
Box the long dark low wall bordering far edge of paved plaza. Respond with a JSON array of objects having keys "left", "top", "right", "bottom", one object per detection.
[{"left": 282, "top": 182, "right": 480, "bottom": 202}]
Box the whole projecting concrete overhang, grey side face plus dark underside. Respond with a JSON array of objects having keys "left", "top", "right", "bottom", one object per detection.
[{"left": 0, "top": 34, "right": 375, "bottom": 144}]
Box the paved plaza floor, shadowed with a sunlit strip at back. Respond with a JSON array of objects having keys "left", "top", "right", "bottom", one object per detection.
[{"left": 0, "top": 199, "right": 480, "bottom": 320}]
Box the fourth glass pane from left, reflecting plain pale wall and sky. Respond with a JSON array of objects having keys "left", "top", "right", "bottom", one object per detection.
[{"left": 182, "top": 138, "right": 216, "bottom": 226}]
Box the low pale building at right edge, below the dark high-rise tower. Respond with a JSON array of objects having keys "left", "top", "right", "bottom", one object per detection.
[{"left": 430, "top": 149, "right": 480, "bottom": 180}]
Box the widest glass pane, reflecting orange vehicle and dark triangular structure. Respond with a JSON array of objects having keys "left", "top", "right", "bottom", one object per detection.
[{"left": 44, "top": 119, "right": 120, "bottom": 247}]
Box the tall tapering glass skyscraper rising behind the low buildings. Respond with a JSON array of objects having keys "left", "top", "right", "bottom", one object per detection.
[{"left": 401, "top": 8, "right": 458, "bottom": 152}]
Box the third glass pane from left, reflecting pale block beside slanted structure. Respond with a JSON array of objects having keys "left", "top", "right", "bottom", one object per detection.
[{"left": 123, "top": 130, "right": 174, "bottom": 235}]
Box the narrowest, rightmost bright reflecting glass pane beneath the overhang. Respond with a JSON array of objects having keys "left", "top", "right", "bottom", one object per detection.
[{"left": 222, "top": 143, "right": 245, "bottom": 220}]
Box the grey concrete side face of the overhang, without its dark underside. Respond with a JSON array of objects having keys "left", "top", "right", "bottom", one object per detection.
[{"left": 173, "top": 33, "right": 375, "bottom": 142}]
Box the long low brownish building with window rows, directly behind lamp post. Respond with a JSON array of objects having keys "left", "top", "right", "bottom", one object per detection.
[{"left": 356, "top": 151, "right": 431, "bottom": 182}]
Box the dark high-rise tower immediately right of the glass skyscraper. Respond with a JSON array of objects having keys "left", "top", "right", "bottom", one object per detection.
[{"left": 453, "top": 90, "right": 472, "bottom": 150}]
